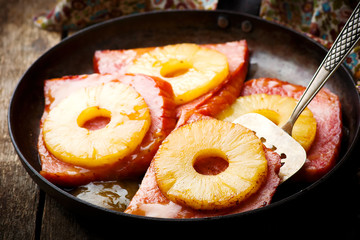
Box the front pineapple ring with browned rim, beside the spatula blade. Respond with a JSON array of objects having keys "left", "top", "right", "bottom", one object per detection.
[{"left": 154, "top": 119, "right": 267, "bottom": 210}]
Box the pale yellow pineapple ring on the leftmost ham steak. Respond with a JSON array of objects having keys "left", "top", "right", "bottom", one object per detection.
[{"left": 43, "top": 82, "right": 151, "bottom": 168}]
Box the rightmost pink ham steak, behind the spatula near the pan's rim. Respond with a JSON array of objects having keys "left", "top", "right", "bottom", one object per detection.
[{"left": 241, "top": 78, "right": 342, "bottom": 182}]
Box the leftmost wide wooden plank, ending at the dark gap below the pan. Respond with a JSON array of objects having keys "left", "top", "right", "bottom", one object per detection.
[{"left": 0, "top": 0, "right": 60, "bottom": 239}]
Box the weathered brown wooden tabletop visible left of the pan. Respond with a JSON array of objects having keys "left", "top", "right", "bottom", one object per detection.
[{"left": 0, "top": 0, "right": 105, "bottom": 239}]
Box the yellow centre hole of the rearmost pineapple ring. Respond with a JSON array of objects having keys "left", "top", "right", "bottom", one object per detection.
[{"left": 160, "top": 59, "right": 192, "bottom": 78}]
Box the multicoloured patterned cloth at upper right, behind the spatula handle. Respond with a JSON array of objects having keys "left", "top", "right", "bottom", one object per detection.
[{"left": 260, "top": 0, "right": 360, "bottom": 92}]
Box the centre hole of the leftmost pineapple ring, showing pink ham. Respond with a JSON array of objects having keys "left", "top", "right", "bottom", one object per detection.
[{"left": 77, "top": 107, "right": 111, "bottom": 131}]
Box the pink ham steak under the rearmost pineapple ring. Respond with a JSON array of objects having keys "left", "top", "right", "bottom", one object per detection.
[{"left": 94, "top": 40, "right": 249, "bottom": 127}]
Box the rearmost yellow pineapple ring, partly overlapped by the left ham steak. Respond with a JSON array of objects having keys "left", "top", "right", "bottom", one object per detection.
[{"left": 127, "top": 43, "right": 229, "bottom": 105}]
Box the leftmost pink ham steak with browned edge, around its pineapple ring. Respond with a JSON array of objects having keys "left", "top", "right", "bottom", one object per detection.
[{"left": 38, "top": 74, "right": 176, "bottom": 187}]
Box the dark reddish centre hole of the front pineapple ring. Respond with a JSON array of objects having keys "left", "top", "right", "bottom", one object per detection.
[{"left": 193, "top": 153, "right": 229, "bottom": 175}]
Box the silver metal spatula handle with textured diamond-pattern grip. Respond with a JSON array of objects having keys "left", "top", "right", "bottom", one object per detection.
[{"left": 282, "top": 3, "right": 360, "bottom": 135}]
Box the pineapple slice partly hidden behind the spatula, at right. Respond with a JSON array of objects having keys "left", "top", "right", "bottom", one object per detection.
[{"left": 217, "top": 94, "right": 316, "bottom": 151}]
